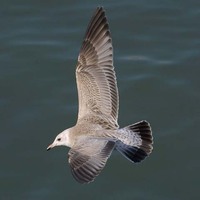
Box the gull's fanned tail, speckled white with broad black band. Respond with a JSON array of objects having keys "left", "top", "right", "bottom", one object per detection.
[{"left": 116, "top": 121, "right": 153, "bottom": 162}]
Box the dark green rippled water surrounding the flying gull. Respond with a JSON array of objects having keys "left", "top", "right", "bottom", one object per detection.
[{"left": 0, "top": 0, "right": 200, "bottom": 200}]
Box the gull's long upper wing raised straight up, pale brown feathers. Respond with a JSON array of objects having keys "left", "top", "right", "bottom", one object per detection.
[{"left": 76, "top": 7, "right": 119, "bottom": 127}]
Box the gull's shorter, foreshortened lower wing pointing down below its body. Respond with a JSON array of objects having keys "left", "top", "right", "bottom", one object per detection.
[{"left": 68, "top": 140, "right": 115, "bottom": 183}]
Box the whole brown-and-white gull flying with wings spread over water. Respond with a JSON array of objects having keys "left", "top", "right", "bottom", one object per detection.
[{"left": 47, "top": 7, "right": 153, "bottom": 183}]
